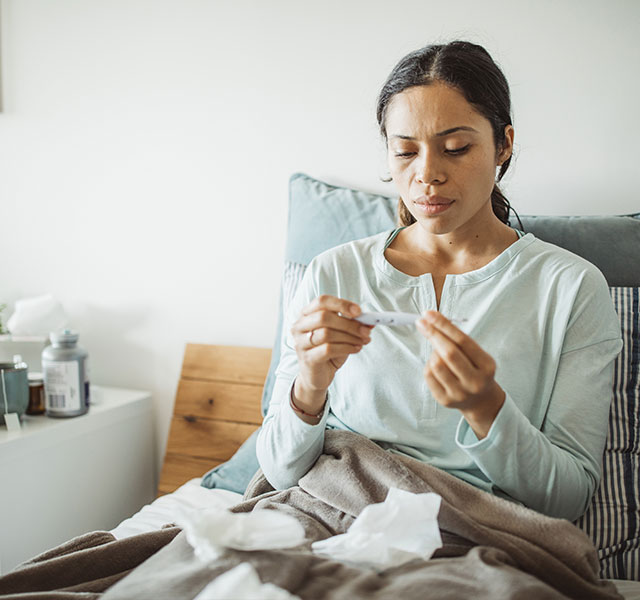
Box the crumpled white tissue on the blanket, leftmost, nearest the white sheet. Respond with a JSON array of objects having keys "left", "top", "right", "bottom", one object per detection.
[{"left": 176, "top": 507, "right": 305, "bottom": 562}]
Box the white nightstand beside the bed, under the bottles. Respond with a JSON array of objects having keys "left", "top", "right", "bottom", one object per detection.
[{"left": 0, "top": 386, "right": 156, "bottom": 573}]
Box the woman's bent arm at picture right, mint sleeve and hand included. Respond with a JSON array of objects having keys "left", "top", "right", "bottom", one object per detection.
[{"left": 421, "top": 279, "right": 622, "bottom": 520}]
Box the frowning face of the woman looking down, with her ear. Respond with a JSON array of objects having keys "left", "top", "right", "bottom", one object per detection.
[{"left": 385, "top": 82, "right": 513, "bottom": 234}]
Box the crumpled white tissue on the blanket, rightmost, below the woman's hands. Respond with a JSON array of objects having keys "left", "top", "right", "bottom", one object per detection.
[{"left": 311, "top": 488, "right": 442, "bottom": 570}]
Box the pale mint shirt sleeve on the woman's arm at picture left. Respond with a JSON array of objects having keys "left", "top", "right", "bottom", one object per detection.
[{"left": 256, "top": 262, "right": 329, "bottom": 490}]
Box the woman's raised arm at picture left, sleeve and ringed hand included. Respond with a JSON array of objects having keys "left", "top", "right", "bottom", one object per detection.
[{"left": 256, "top": 269, "right": 371, "bottom": 489}]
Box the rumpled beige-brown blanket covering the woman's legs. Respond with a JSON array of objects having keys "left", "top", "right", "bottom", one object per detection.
[{"left": 0, "top": 431, "right": 621, "bottom": 600}]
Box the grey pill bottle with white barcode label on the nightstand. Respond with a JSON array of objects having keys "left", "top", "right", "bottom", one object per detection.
[{"left": 42, "top": 329, "right": 89, "bottom": 417}]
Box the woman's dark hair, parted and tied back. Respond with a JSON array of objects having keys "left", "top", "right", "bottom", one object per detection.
[{"left": 376, "top": 41, "right": 522, "bottom": 225}]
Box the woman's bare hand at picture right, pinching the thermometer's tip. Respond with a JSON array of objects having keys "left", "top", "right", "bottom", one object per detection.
[{"left": 416, "top": 311, "right": 505, "bottom": 439}]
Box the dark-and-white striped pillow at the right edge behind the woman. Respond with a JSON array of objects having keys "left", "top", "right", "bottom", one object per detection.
[{"left": 576, "top": 287, "right": 640, "bottom": 580}]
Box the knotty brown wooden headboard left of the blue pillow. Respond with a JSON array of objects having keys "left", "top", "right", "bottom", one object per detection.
[{"left": 158, "top": 344, "right": 271, "bottom": 495}]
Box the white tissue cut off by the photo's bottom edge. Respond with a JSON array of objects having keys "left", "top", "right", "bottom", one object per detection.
[{"left": 193, "top": 563, "right": 300, "bottom": 600}]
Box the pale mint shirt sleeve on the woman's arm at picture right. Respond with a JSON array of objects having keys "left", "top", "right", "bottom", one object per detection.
[{"left": 456, "top": 270, "right": 622, "bottom": 521}]
